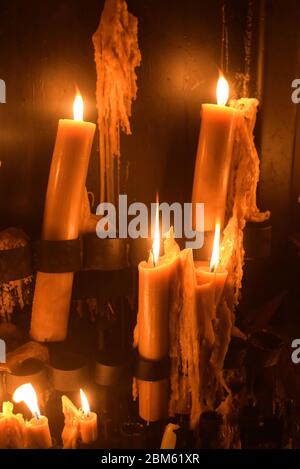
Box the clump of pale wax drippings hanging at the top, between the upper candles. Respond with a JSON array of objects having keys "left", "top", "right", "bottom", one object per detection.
[{"left": 93, "top": 0, "right": 141, "bottom": 203}]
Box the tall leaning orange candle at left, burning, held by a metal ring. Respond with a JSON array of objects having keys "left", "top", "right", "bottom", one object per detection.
[{"left": 30, "top": 92, "right": 96, "bottom": 342}]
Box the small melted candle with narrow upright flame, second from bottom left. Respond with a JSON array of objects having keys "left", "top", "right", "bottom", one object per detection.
[{"left": 62, "top": 389, "right": 98, "bottom": 449}]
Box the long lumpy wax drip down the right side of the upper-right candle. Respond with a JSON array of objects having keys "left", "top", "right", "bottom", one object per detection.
[{"left": 220, "top": 98, "right": 270, "bottom": 307}]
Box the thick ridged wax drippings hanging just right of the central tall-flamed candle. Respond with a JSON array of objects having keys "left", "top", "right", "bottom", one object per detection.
[{"left": 169, "top": 243, "right": 232, "bottom": 429}]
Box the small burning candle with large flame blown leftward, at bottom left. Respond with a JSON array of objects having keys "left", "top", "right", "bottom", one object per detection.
[{"left": 13, "top": 383, "right": 52, "bottom": 449}]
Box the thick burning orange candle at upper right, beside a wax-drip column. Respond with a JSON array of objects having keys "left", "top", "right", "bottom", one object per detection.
[{"left": 192, "top": 76, "right": 239, "bottom": 231}]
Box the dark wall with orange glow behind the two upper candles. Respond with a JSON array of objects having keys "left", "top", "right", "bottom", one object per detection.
[{"left": 0, "top": 0, "right": 300, "bottom": 255}]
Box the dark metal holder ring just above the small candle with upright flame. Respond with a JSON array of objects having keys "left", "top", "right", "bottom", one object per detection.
[{"left": 50, "top": 352, "right": 88, "bottom": 393}]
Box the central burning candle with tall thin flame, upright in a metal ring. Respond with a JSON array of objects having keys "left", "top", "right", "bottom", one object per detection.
[{"left": 137, "top": 197, "right": 179, "bottom": 422}]
